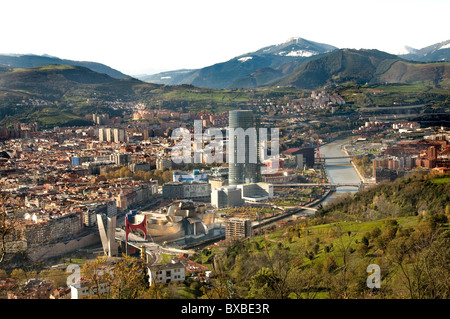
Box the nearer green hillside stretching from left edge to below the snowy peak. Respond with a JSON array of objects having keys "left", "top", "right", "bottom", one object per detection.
[{"left": 0, "top": 65, "right": 292, "bottom": 128}]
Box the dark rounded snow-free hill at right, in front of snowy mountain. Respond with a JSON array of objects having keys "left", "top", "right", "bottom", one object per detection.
[{"left": 270, "top": 49, "right": 450, "bottom": 89}]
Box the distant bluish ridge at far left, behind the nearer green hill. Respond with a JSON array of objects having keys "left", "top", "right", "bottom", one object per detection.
[{"left": 0, "top": 54, "right": 130, "bottom": 79}]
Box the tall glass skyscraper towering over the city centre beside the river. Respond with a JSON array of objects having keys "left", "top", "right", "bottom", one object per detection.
[{"left": 227, "top": 110, "right": 260, "bottom": 185}]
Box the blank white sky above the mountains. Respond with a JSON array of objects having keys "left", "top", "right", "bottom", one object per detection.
[{"left": 0, "top": 0, "right": 450, "bottom": 75}]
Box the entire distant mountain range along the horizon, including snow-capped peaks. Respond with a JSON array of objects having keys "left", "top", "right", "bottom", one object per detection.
[{"left": 0, "top": 37, "right": 450, "bottom": 89}]
